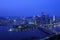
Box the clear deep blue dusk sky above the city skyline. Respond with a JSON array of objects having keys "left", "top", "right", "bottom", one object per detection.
[{"left": 0, "top": 0, "right": 60, "bottom": 17}]
